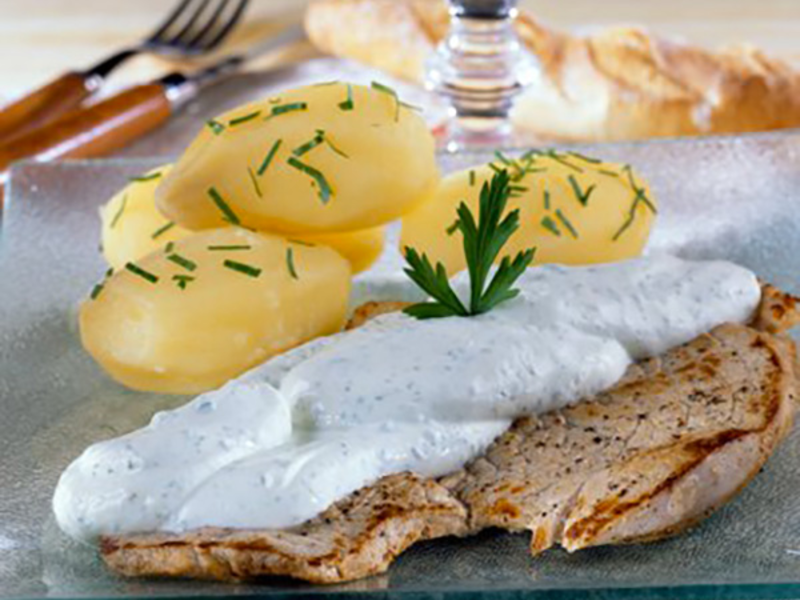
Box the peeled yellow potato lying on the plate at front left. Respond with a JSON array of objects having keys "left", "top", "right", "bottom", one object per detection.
[{"left": 79, "top": 227, "right": 351, "bottom": 394}]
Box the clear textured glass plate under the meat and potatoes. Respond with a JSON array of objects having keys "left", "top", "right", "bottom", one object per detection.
[{"left": 0, "top": 132, "right": 800, "bottom": 599}]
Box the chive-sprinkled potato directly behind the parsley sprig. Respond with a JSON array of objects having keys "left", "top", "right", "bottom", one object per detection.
[{"left": 400, "top": 151, "right": 656, "bottom": 275}]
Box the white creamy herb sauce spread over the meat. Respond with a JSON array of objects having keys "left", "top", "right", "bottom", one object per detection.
[{"left": 53, "top": 256, "right": 760, "bottom": 540}]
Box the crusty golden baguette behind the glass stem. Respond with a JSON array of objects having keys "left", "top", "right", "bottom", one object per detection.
[{"left": 306, "top": 0, "right": 800, "bottom": 141}]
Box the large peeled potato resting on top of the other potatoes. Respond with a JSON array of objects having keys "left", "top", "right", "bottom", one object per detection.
[{"left": 156, "top": 83, "right": 438, "bottom": 235}]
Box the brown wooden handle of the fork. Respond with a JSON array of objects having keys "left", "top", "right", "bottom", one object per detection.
[{"left": 0, "top": 72, "right": 96, "bottom": 143}]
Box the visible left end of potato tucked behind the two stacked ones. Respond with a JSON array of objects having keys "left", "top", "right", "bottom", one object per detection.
[{"left": 100, "top": 165, "right": 187, "bottom": 269}]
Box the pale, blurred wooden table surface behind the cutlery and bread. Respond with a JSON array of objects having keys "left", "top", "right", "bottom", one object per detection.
[{"left": 0, "top": 0, "right": 800, "bottom": 98}]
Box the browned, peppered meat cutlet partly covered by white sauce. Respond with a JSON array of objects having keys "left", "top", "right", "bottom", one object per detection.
[{"left": 101, "top": 286, "right": 798, "bottom": 583}]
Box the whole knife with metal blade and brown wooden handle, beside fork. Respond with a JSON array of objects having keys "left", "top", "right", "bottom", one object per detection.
[{"left": 0, "top": 25, "right": 305, "bottom": 198}]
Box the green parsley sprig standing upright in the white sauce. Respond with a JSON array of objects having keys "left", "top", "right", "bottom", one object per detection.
[{"left": 404, "top": 169, "right": 535, "bottom": 319}]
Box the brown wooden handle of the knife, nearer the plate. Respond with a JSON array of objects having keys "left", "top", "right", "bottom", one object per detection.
[{"left": 0, "top": 83, "right": 171, "bottom": 185}]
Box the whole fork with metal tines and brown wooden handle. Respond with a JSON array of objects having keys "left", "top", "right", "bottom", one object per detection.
[{"left": 0, "top": 0, "right": 248, "bottom": 144}]
